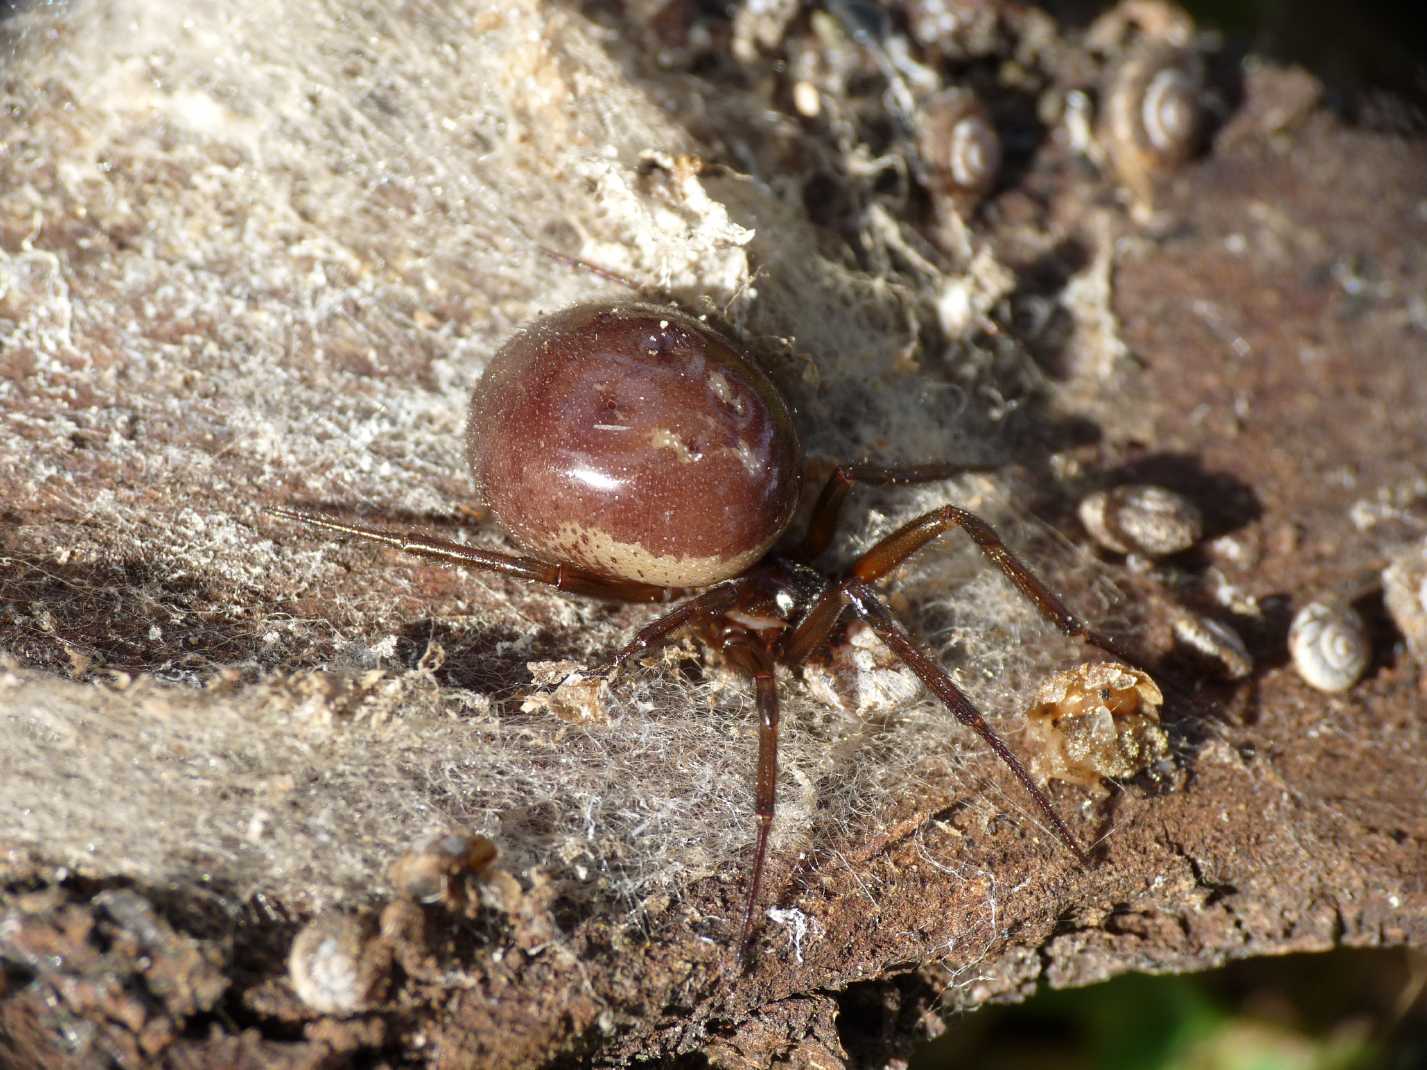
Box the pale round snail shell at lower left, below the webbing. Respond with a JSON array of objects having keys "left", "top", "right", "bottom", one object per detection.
[{"left": 287, "top": 913, "right": 391, "bottom": 1016}]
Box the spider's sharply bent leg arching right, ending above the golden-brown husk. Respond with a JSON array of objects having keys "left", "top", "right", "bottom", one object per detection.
[{"left": 849, "top": 505, "right": 1134, "bottom": 665}]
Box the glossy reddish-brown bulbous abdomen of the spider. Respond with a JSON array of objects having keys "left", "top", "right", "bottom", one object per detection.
[{"left": 467, "top": 304, "right": 801, "bottom": 586}]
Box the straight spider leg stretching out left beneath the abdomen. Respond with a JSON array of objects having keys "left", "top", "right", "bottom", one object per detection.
[{"left": 267, "top": 506, "right": 679, "bottom": 602}]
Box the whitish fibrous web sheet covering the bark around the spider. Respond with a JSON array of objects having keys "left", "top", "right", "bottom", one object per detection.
[{"left": 0, "top": 0, "right": 1113, "bottom": 924}]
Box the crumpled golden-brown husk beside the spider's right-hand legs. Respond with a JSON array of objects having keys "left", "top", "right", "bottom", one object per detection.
[{"left": 1026, "top": 662, "right": 1169, "bottom": 785}]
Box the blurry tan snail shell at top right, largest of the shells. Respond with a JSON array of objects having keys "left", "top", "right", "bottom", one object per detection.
[{"left": 1102, "top": 41, "right": 1203, "bottom": 203}]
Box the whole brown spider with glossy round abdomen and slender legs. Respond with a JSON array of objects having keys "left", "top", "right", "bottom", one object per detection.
[{"left": 271, "top": 302, "right": 1120, "bottom": 947}]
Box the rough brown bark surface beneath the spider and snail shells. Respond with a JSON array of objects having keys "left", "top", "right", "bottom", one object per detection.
[{"left": 0, "top": 3, "right": 1427, "bottom": 1067}]
